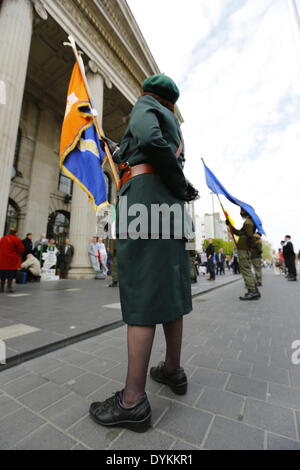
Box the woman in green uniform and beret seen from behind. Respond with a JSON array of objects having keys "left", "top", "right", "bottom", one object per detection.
[{"left": 90, "top": 75, "right": 198, "bottom": 432}]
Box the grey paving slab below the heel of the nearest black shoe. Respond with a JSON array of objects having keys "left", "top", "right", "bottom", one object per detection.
[{"left": 110, "top": 429, "right": 175, "bottom": 450}]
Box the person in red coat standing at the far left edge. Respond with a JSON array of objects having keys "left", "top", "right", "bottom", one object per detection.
[{"left": 0, "top": 228, "right": 24, "bottom": 293}]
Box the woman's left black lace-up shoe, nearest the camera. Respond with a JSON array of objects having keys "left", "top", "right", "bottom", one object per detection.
[{"left": 90, "top": 391, "right": 151, "bottom": 432}]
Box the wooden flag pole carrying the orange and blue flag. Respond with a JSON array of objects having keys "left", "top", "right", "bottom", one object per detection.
[{"left": 64, "top": 35, "right": 120, "bottom": 190}]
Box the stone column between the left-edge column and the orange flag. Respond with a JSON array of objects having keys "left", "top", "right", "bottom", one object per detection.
[{"left": 24, "top": 107, "right": 58, "bottom": 240}]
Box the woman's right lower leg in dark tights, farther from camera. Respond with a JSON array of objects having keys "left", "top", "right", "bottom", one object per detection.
[{"left": 163, "top": 317, "right": 183, "bottom": 372}]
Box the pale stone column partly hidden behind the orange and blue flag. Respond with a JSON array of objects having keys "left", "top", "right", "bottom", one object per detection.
[{"left": 69, "top": 64, "right": 104, "bottom": 279}]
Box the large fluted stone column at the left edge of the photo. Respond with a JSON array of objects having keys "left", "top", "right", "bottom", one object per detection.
[{"left": 0, "top": 0, "right": 33, "bottom": 236}]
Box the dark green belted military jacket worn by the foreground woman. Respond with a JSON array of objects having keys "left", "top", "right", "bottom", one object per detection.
[{"left": 114, "top": 96, "right": 186, "bottom": 238}]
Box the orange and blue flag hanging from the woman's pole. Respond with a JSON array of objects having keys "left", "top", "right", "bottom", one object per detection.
[{"left": 60, "top": 63, "right": 108, "bottom": 210}]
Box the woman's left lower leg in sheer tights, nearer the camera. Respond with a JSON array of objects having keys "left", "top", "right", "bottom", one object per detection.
[{"left": 123, "top": 325, "right": 155, "bottom": 405}]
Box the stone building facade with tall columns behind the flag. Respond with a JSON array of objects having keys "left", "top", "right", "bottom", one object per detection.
[{"left": 0, "top": 0, "right": 164, "bottom": 278}]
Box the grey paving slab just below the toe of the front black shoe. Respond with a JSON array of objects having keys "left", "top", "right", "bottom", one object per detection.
[{"left": 68, "top": 416, "right": 123, "bottom": 450}]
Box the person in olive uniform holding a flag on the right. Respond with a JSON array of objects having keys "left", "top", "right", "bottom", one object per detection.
[{"left": 226, "top": 209, "right": 261, "bottom": 300}]
